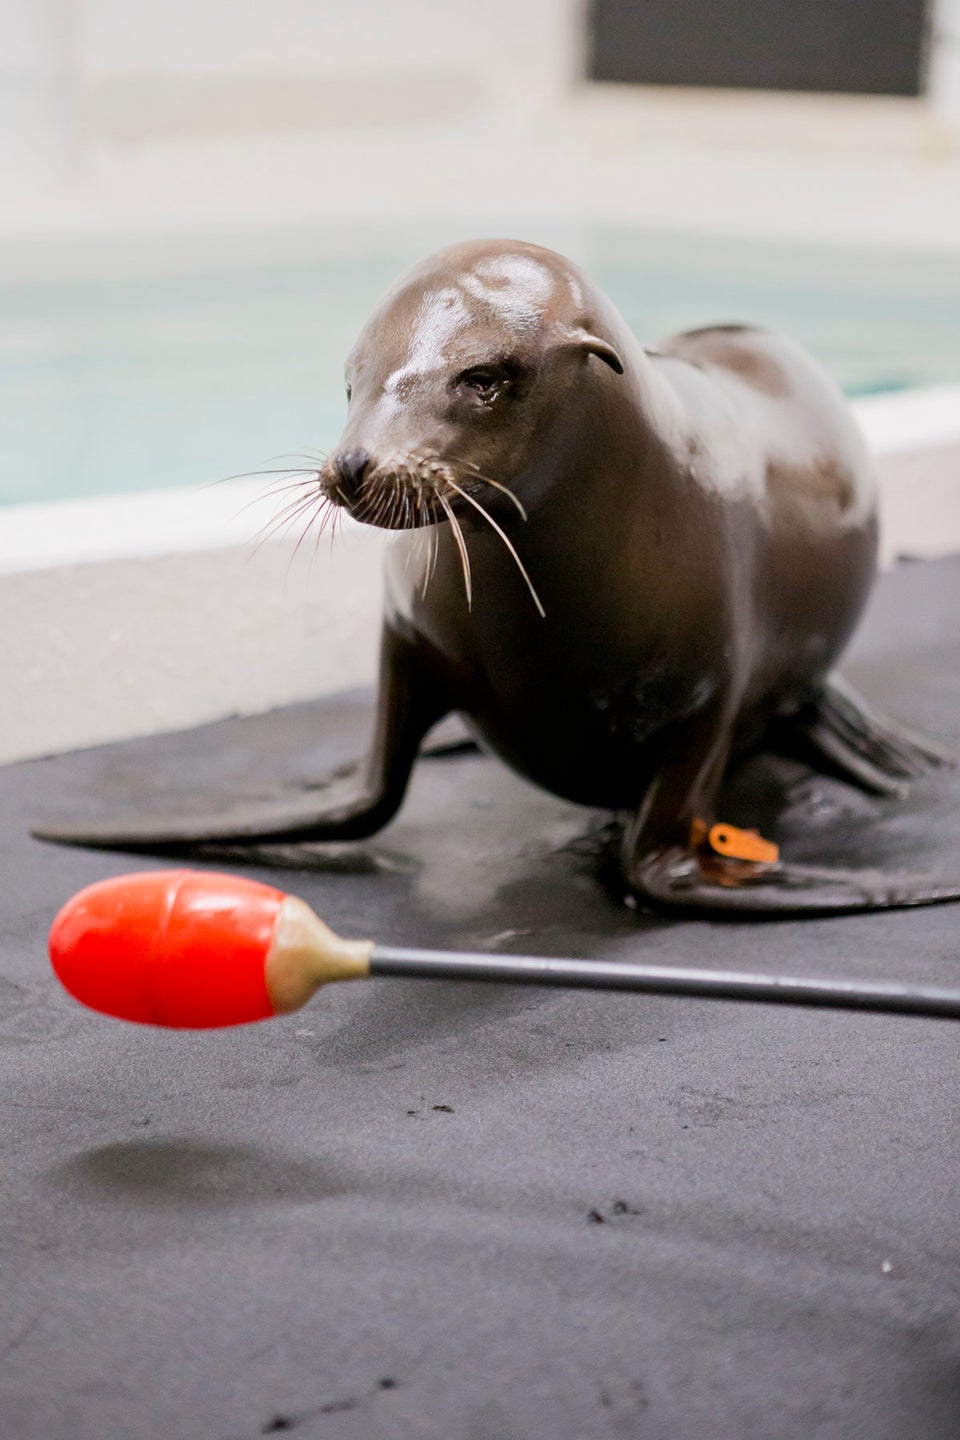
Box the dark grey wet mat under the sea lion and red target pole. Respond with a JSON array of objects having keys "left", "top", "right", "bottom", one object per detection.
[{"left": 0, "top": 562, "right": 960, "bottom": 1440}]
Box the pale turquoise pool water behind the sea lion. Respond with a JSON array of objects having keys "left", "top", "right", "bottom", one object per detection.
[{"left": 0, "top": 232, "right": 960, "bottom": 504}]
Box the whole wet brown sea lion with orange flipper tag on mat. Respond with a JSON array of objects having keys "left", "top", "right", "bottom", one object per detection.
[{"left": 33, "top": 240, "right": 960, "bottom": 913}]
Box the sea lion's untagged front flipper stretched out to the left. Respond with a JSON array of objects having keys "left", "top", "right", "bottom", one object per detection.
[{"left": 33, "top": 626, "right": 449, "bottom": 854}]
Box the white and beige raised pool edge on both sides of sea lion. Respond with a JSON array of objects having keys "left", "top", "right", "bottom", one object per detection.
[{"left": 0, "top": 386, "right": 960, "bottom": 763}]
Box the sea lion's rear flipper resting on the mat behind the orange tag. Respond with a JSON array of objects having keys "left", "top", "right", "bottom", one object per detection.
[{"left": 774, "top": 675, "right": 957, "bottom": 795}]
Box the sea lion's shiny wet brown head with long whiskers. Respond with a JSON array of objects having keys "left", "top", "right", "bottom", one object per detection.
[{"left": 318, "top": 240, "right": 623, "bottom": 530}]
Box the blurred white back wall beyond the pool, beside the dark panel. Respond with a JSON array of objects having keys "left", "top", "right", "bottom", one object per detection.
[{"left": 0, "top": 0, "right": 960, "bottom": 199}]
